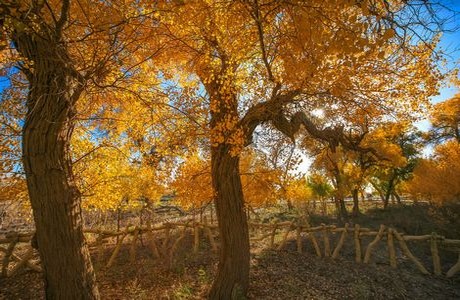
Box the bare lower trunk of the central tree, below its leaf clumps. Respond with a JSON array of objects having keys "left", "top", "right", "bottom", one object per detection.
[{"left": 209, "top": 144, "right": 249, "bottom": 299}]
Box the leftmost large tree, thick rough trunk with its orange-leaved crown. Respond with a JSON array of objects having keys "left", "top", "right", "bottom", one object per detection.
[{"left": 0, "top": 0, "right": 162, "bottom": 299}]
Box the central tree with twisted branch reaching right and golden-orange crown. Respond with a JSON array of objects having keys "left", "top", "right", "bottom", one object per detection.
[{"left": 158, "top": 0, "right": 439, "bottom": 299}]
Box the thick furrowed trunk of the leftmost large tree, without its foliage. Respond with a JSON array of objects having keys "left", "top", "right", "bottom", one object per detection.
[{"left": 15, "top": 29, "right": 99, "bottom": 300}]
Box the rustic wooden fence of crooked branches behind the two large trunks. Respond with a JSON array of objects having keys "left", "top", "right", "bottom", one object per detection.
[{"left": 0, "top": 221, "right": 460, "bottom": 277}]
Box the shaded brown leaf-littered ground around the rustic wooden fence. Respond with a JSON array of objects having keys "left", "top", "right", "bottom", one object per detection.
[{"left": 0, "top": 206, "right": 460, "bottom": 300}]
